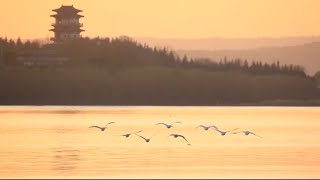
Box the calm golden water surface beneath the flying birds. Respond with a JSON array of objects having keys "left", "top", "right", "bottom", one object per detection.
[{"left": 0, "top": 106, "right": 320, "bottom": 178}]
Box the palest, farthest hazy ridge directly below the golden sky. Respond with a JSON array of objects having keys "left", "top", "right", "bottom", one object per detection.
[{"left": 134, "top": 36, "right": 320, "bottom": 51}]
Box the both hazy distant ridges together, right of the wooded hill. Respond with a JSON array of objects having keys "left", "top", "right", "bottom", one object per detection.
[{"left": 136, "top": 36, "right": 320, "bottom": 75}]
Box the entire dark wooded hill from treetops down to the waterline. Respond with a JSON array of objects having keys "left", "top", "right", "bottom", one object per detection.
[{"left": 0, "top": 37, "right": 319, "bottom": 105}]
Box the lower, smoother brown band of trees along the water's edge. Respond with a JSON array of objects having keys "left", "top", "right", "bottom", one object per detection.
[{"left": 0, "top": 66, "right": 319, "bottom": 105}]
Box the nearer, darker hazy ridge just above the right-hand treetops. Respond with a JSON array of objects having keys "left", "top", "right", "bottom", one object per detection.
[{"left": 177, "top": 41, "right": 320, "bottom": 75}]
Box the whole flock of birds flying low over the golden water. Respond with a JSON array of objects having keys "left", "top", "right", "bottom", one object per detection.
[{"left": 89, "top": 121, "right": 262, "bottom": 145}]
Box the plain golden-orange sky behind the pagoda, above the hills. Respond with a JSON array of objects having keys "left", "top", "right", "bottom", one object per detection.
[{"left": 0, "top": 0, "right": 320, "bottom": 38}]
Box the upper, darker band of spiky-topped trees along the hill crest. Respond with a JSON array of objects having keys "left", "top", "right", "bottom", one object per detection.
[{"left": 0, "top": 36, "right": 306, "bottom": 77}]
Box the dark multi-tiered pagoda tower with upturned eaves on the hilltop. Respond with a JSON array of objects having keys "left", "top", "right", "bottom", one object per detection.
[{"left": 50, "top": 5, "right": 84, "bottom": 43}]
